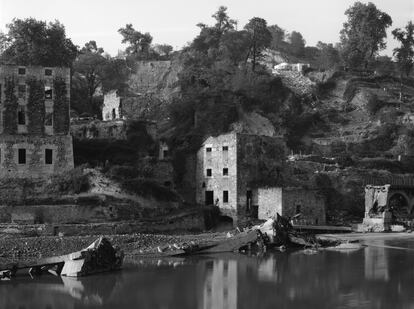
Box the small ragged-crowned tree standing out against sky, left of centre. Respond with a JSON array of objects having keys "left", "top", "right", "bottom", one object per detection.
[{"left": 118, "top": 24, "right": 152, "bottom": 58}]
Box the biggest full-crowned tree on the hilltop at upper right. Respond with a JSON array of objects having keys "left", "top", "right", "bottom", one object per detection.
[{"left": 340, "top": 2, "right": 392, "bottom": 69}]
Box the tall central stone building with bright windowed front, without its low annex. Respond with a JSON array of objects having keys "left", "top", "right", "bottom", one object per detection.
[{"left": 196, "top": 133, "right": 285, "bottom": 221}]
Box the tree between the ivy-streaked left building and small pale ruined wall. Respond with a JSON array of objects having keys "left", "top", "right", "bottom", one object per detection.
[{"left": 74, "top": 41, "right": 107, "bottom": 109}]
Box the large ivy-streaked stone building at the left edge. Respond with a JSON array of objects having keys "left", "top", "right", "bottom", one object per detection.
[{"left": 0, "top": 65, "right": 74, "bottom": 178}]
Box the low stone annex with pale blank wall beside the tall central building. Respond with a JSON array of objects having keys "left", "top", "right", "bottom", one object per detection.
[{"left": 253, "top": 187, "right": 326, "bottom": 225}]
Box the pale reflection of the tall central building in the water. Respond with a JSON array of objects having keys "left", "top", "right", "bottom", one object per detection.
[{"left": 200, "top": 260, "right": 237, "bottom": 309}]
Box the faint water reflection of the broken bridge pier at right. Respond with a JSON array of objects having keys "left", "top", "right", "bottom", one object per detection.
[{"left": 364, "top": 240, "right": 389, "bottom": 281}]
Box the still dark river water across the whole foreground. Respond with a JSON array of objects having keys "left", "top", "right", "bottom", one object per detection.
[{"left": 0, "top": 238, "right": 414, "bottom": 309}]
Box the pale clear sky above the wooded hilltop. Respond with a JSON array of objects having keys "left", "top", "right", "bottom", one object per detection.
[{"left": 0, "top": 0, "right": 414, "bottom": 56}]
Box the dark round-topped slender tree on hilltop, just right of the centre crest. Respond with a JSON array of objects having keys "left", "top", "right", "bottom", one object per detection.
[{"left": 244, "top": 17, "right": 272, "bottom": 71}]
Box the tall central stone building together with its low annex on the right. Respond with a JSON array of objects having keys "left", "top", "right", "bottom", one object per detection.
[{"left": 195, "top": 133, "right": 326, "bottom": 225}]
